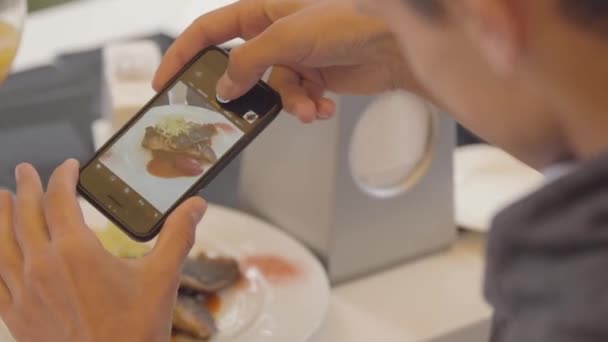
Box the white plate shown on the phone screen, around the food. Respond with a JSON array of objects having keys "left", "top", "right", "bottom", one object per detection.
[{"left": 104, "top": 105, "right": 243, "bottom": 212}]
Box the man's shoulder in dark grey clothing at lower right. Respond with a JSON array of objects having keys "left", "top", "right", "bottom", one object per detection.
[{"left": 485, "top": 152, "right": 608, "bottom": 342}]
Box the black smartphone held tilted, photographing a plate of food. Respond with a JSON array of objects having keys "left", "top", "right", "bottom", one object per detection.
[{"left": 78, "top": 47, "right": 282, "bottom": 242}]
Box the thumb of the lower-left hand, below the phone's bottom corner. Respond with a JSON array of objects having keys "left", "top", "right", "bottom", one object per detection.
[{"left": 152, "top": 197, "right": 207, "bottom": 272}]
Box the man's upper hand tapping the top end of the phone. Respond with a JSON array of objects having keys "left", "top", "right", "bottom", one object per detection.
[{"left": 154, "top": 0, "right": 416, "bottom": 122}]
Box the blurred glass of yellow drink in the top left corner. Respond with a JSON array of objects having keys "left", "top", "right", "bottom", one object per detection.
[{"left": 0, "top": 0, "right": 27, "bottom": 83}]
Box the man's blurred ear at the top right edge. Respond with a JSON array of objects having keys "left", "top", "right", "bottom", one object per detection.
[{"left": 459, "top": 0, "right": 534, "bottom": 77}]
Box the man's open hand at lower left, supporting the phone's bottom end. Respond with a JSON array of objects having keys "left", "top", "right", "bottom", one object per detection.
[{"left": 0, "top": 161, "right": 206, "bottom": 342}]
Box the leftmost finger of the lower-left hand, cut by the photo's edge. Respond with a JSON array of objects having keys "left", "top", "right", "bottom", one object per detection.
[{"left": 0, "top": 190, "right": 23, "bottom": 301}]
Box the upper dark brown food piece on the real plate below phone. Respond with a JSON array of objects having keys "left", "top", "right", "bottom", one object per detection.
[{"left": 180, "top": 254, "right": 241, "bottom": 293}]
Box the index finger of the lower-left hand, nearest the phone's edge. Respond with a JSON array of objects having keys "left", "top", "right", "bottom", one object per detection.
[{"left": 44, "top": 160, "right": 85, "bottom": 240}]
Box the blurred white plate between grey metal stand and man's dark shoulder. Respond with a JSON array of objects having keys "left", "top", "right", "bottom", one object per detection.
[{"left": 454, "top": 144, "right": 543, "bottom": 232}]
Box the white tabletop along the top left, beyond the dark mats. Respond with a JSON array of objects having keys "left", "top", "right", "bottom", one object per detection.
[{"left": 13, "top": 0, "right": 231, "bottom": 71}]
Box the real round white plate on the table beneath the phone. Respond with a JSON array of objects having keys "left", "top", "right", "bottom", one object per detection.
[{"left": 0, "top": 201, "right": 330, "bottom": 342}]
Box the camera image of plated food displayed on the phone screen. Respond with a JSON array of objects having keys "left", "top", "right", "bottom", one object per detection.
[{"left": 100, "top": 82, "right": 249, "bottom": 212}]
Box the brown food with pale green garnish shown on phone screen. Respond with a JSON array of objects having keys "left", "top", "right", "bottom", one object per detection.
[{"left": 141, "top": 116, "right": 220, "bottom": 178}]
